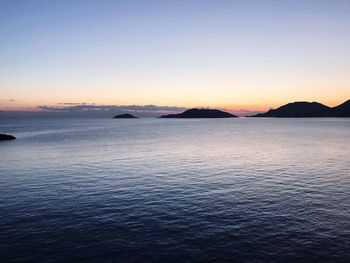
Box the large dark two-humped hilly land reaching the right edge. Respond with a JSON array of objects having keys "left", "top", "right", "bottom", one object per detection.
[{"left": 248, "top": 100, "right": 350, "bottom": 118}]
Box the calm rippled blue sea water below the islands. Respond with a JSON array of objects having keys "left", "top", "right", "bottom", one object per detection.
[{"left": 0, "top": 119, "right": 350, "bottom": 262}]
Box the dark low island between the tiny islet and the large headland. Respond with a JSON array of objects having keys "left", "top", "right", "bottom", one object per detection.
[{"left": 160, "top": 109, "right": 237, "bottom": 119}]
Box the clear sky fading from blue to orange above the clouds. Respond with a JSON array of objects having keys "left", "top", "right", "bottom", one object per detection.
[{"left": 0, "top": 0, "right": 350, "bottom": 110}]
